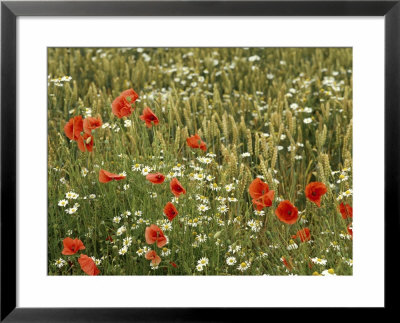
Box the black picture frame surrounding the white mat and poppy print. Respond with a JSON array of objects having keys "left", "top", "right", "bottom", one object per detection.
[{"left": 0, "top": 0, "right": 400, "bottom": 322}]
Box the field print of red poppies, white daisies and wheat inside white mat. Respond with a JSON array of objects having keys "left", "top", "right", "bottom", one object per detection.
[{"left": 48, "top": 48, "right": 353, "bottom": 276}]
